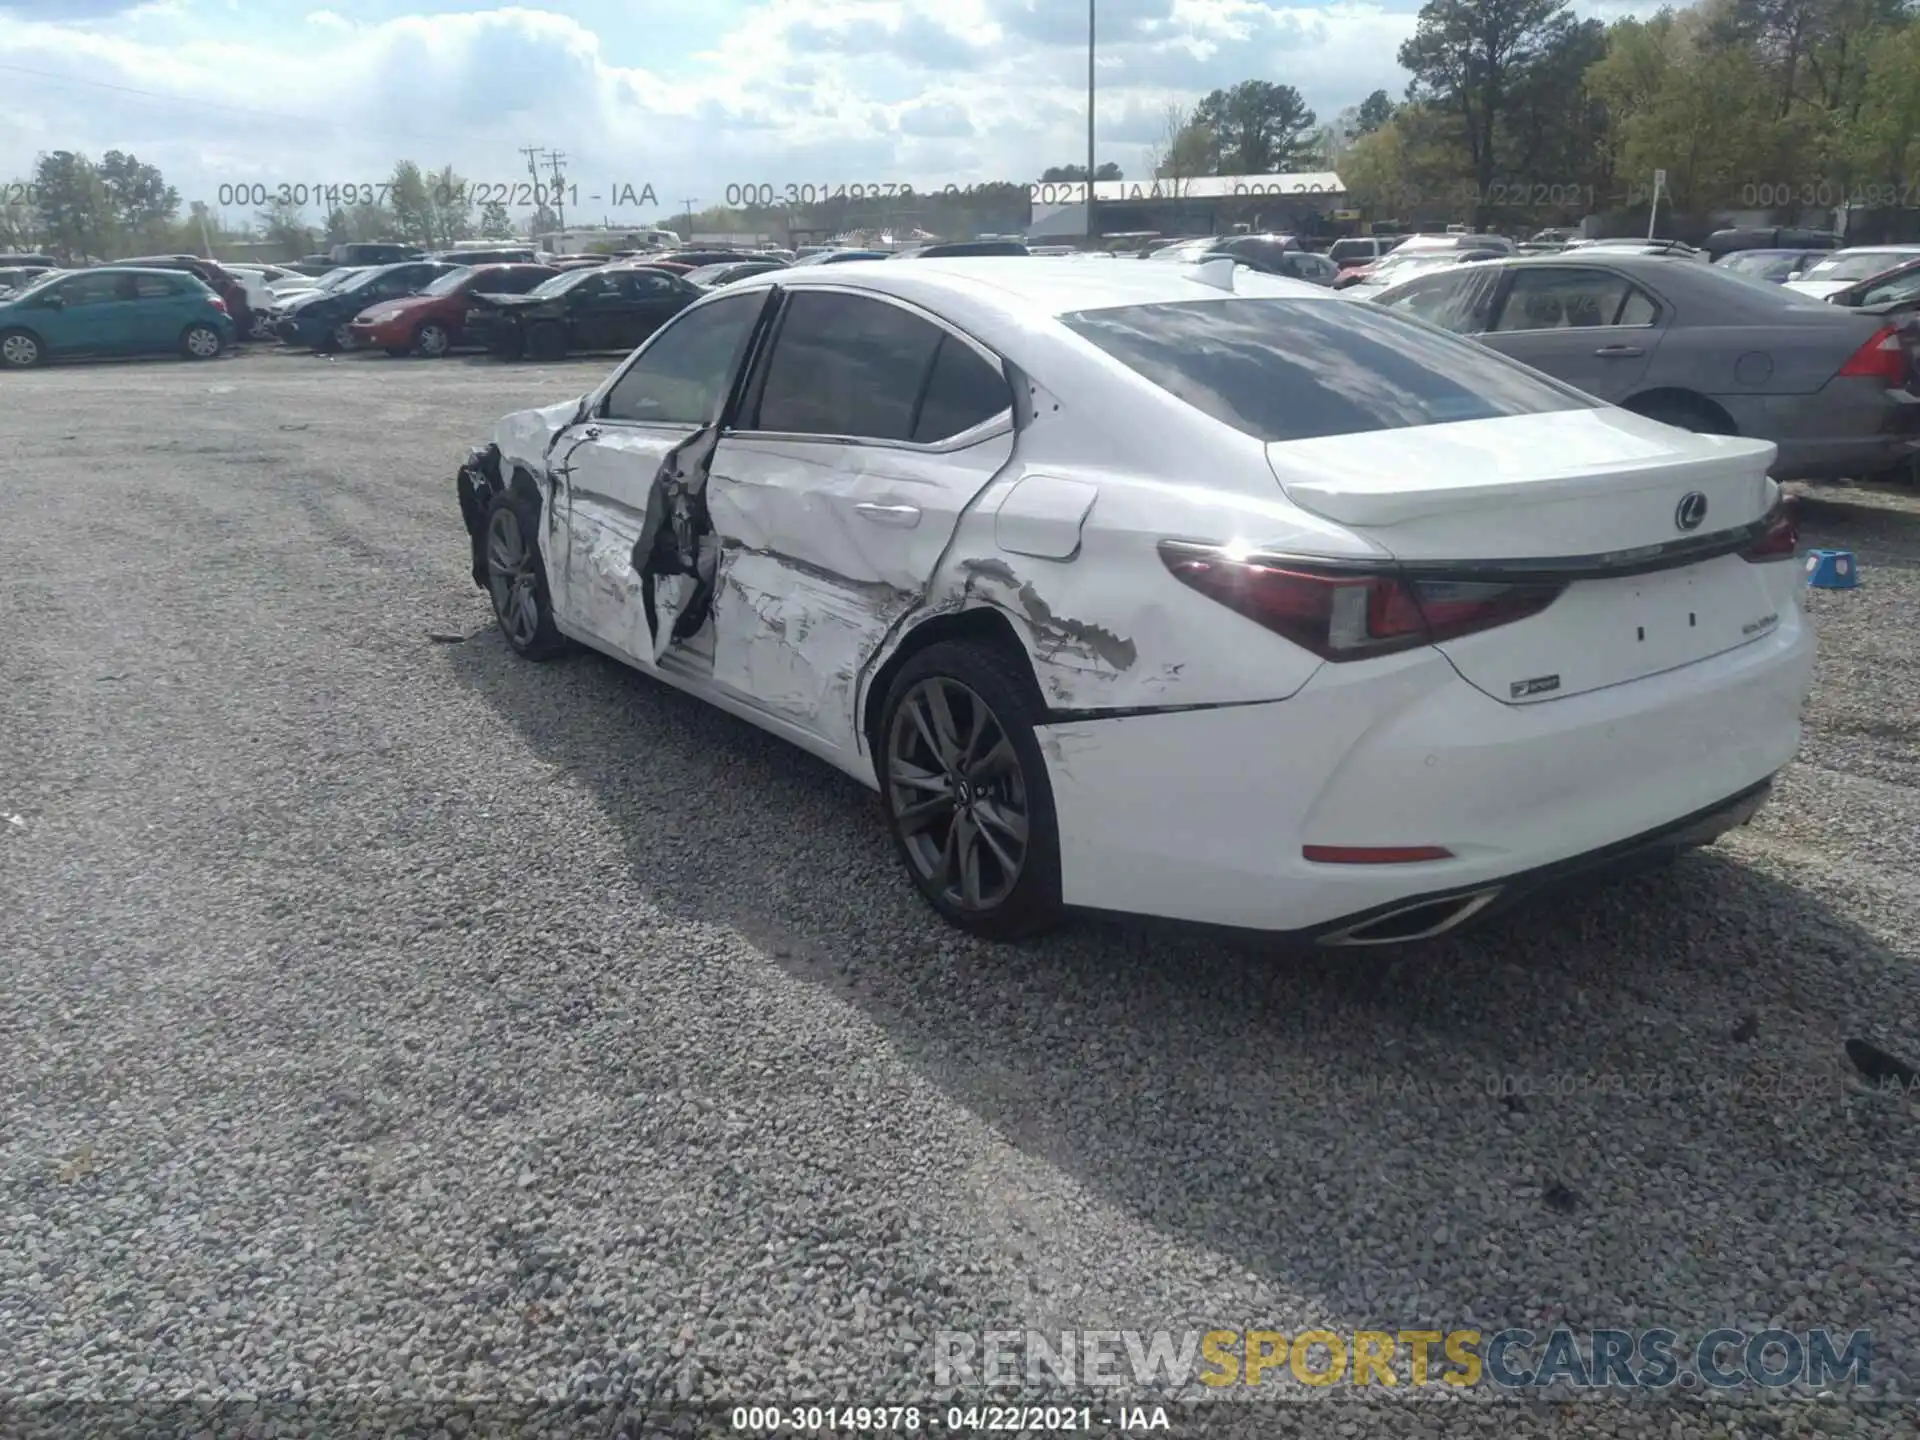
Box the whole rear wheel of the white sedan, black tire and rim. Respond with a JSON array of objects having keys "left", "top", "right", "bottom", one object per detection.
[{"left": 874, "top": 641, "right": 1062, "bottom": 941}]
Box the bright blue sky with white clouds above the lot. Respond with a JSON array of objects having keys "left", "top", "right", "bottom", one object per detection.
[{"left": 0, "top": 0, "right": 1582, "bottom": 223}]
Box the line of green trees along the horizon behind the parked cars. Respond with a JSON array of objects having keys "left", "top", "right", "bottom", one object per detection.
[{"left": 15, "top": 0, "right": 1920, "bottom": 259}]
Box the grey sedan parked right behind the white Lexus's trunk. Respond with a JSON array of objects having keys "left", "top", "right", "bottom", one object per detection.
[{"left": 1373, "top": 250, "right": 1920, "bottom": 480}]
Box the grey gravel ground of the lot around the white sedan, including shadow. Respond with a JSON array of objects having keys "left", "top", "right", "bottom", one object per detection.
[{"left": 0, "top": 353, "right": 1920, "bottom": 1440}]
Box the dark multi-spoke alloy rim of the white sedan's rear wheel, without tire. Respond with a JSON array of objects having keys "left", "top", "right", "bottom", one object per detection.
[{"left": 887, "top": 676, "right": 1029, "bottom": 912}]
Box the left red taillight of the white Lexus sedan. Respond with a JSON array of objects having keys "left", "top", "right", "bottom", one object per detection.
[{"left": 1160, "top": 541, "right": 1565, "bottom": 660}]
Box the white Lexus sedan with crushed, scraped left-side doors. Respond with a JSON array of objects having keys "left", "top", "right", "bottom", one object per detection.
[{"left": 457, "top": 257, "right": 1812, "bottom": 945}]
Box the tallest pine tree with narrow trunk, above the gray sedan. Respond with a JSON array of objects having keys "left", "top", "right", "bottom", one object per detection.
[{"left": 1400, "top": 0, "right": 1569, "bottom": 225}]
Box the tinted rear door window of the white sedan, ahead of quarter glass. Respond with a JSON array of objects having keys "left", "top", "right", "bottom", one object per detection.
[{"left": 751, "top": 290, "right": 958, "bottom": 442}]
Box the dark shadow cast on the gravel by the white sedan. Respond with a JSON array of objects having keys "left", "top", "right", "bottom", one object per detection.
[{"left": 436, "top": 628, "right": 1912, "bottom": 1351}]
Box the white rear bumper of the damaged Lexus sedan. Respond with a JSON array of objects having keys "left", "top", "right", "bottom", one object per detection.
[{"left": 1039, "top": 607, "right": 1812, "bottom": 939}]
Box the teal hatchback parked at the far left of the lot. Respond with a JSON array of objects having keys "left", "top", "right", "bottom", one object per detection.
[{"left": 0, "top": 265, "right": 234, "bottom": 371}]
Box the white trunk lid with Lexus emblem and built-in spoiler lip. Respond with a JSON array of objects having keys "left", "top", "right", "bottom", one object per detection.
[{"left": 1267, "top": 407, "right": 1799, "bottom": 705}]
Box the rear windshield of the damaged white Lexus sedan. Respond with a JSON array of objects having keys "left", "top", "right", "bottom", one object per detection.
[{"left": 1060, "top": 298, "right": 1599, "bottom": 442}]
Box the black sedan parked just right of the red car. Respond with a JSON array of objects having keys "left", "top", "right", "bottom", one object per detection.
[{"left": 465, "top": 265, "right": 707, "bottom": 359}]
